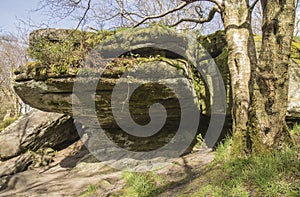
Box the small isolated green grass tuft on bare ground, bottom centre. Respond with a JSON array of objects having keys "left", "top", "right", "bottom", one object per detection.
[{"left": 123, "top": 172, "right": 163, "bottom": 197}]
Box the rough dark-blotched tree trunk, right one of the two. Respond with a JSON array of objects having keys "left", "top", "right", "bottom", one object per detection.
[{"left": 249, "top": 0, "right": 295, "bottom": 153}]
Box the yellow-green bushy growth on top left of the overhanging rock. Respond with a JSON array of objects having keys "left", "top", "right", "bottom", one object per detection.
[{"left": 27, "top": 31, "right": 115, "bottom": 75}]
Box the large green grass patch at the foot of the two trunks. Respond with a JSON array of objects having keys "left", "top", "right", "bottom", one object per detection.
[{"left": 192, "top": 136, "right": 300, "bottom": 196}]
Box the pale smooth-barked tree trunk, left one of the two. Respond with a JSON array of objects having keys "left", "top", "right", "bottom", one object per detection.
[{"left": 222, "top": 0, "right": 256, "bottom": 155}]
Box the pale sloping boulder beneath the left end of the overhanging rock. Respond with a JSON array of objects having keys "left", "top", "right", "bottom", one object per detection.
[{"left": 0, "top": 109, "right": 79, "bottom": 161}]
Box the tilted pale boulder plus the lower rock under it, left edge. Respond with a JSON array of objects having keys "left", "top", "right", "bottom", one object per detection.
[{"left": 0, "top": 109, "right": 79, "bottom": 177}]
